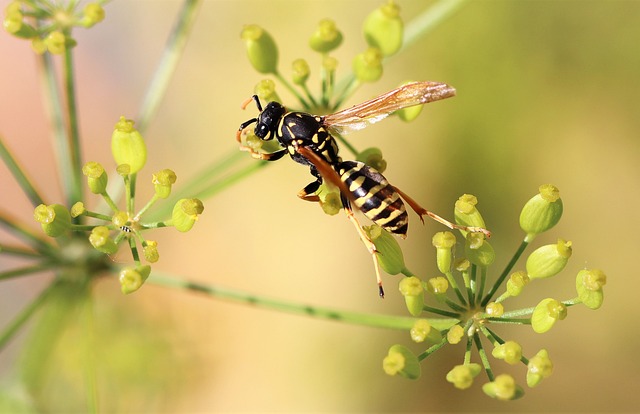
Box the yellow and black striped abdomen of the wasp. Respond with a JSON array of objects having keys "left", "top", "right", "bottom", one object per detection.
[{"left": 336, "top": 161, "right": 409, "bottom": 237}]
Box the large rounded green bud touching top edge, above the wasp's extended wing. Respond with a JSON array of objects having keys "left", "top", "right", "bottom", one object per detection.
[{"left": 363, "top": 1, "right": 404, "bottom": 56}]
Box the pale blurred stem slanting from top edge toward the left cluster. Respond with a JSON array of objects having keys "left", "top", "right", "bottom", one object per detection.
[{"left": 136, "top": 0, "right": 202, "bottom": 133}]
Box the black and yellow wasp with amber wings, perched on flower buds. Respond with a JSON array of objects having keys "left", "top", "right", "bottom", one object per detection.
[{"left": 236, "top": 82, "right": 488, "bottom": 297}]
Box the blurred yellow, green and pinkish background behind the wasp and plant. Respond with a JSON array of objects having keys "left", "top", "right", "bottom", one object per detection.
[{"left": 0, "top": 0, "right": 640, "bottom": 412}]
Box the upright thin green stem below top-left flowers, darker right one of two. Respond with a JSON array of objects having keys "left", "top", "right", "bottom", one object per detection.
[{"left": 64, "top": 48, "right": 83, "bottom": 206}]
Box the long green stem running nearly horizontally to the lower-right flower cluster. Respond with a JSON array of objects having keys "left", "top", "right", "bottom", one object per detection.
[{"left": 147, "top": 272, "right": 456, "bottom": 330}]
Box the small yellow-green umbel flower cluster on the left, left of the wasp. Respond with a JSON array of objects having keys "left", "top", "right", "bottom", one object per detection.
[{"left": 34, "top": 117, "right": 204, "bottom": 293}]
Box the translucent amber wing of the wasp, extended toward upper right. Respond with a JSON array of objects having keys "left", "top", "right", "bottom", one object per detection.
[{"left": 324, "top": 82, "right": 456, "bottom": 134}]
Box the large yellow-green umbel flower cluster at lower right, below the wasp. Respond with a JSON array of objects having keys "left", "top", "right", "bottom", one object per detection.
[{"left": 378, "top": 185, "right": 607, "bottom": 400}]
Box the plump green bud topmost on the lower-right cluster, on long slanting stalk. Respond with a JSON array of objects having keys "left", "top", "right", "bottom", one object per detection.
[{"left": 520, "top": 184, "right": 562, "bottom": 242}]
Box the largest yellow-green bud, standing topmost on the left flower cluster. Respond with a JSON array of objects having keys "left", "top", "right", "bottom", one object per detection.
[{"left": 111, "top": 116, "right": 147, "bottom": 174}]
